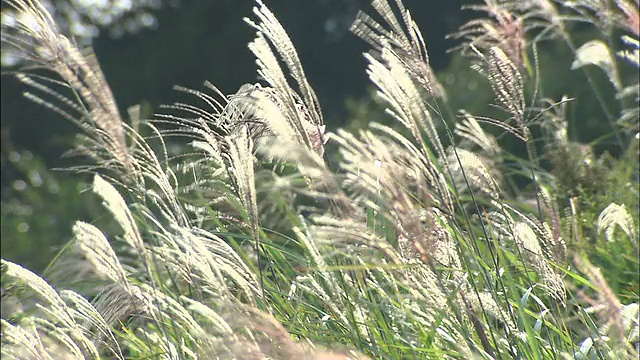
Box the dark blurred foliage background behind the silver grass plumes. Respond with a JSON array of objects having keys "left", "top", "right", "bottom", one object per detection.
[{"left": 1, "top": 0, "right": 637, "bottom": 272}]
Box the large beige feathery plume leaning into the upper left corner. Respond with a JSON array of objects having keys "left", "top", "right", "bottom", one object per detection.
[{"left": 2, "top": 0, "right": 133, "bottom": 174}]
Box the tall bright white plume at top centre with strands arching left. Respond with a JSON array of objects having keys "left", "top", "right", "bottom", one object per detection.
[{"left": 156, "top": 3, "right": 332, "bottom": 223}]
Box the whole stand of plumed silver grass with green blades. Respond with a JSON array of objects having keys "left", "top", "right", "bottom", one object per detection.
[{"left": 1, "top": 0, "right": 640, "bottom": 359}]
